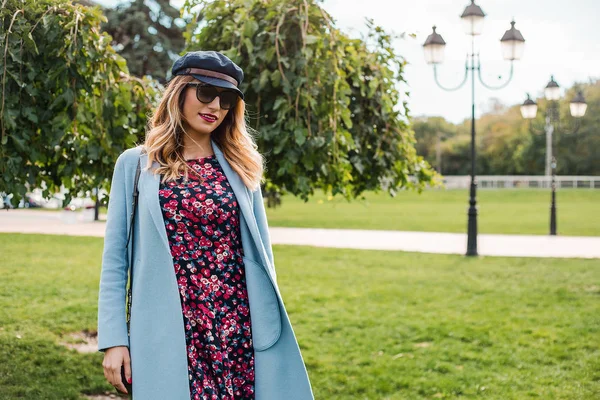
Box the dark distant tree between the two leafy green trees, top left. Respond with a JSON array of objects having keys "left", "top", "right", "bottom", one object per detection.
[{"left": 102, "top": 0, "right": 189, "bottom": 84}]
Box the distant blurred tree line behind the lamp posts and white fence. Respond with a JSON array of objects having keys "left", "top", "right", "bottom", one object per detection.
[{"left": 414, "top": 80, "right": 600, "bottom": 175}]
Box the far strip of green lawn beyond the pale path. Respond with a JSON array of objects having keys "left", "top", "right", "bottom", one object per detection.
[{"left": 267, "top": 189, "right": 600, "bottom": 236}]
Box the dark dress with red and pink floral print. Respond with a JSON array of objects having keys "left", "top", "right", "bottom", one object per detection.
[{"left": 159, "top": 154, "right": 254, "bottom": 400}]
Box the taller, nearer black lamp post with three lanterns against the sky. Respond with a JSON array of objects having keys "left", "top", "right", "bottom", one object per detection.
[{"left": 423, "top": 0, "right": 525, "bottom": 256}]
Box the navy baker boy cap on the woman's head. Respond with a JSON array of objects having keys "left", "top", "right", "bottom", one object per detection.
[{"left": 171, "top": 50, "right": 244, "bottom": 100}]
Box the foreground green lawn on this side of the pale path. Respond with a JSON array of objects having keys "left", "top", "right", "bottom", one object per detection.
[{"left": 0, "top": 234, "right": 600, "bottom": 400}]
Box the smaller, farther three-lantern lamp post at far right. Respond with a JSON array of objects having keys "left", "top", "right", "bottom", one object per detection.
[{"left": 521, "top": 75, "right": 587, "bottom": 236}]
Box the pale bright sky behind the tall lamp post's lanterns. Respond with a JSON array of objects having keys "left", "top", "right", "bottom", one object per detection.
[{"left": 96, "top": 0, "right": 600, "bottom": 123}]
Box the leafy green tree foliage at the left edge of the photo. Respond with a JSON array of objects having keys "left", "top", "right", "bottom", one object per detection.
[{"left": 0, "top": 0, "right": 156, "bottom": 206}]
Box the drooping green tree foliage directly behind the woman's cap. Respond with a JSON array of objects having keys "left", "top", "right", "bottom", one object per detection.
[{"left": 184, "top": 0, "right": 435, "bottom": 201}]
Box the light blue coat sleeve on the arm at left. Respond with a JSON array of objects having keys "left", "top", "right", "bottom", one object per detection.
[{"left": 98, "top": 154, "right": 129, "bottom": 352}]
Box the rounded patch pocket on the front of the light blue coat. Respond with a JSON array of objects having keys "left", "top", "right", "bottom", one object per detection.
[{"left": 243, "top": 257, "right": 281, "bottom": 351}]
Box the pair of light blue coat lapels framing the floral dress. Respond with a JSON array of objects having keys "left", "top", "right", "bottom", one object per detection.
[{"left": 138, "top": 138, "right": 273, "bottom": 279}]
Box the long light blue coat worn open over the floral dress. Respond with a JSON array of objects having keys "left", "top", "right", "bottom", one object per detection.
[{"left": 98, "top": 140, "right": 314, "bottom": 400}]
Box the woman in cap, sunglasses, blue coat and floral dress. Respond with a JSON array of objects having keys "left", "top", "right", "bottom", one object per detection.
[{"left": 98, "top": 51, "right": 313, "bottom": 400}]
